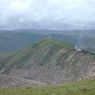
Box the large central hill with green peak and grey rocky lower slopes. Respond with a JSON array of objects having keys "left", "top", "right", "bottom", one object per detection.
[{"left": 0, "top": 38, "right": 95, "bottom": 83}]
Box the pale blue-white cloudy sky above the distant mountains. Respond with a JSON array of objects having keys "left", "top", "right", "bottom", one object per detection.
[{"left": 0, "top": 0, "right": 95, "bottom": 29}]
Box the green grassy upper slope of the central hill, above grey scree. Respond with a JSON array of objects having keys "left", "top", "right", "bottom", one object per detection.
[{"left": 0, "top": 38, "right": 74, "bottom": 72}]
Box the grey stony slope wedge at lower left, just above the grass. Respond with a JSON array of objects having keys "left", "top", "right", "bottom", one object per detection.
[{"left": 0, "top": 74, "right": 47, "bottom": 88}]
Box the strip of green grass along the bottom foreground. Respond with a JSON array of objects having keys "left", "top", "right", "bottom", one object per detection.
[{"left": 0, "top": 80, "right": 95, "bottom": 95}]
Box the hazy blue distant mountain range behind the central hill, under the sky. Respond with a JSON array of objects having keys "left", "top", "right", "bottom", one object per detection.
[{"left": 0, "top": 29, "right": 95, "bottom": 55}]
